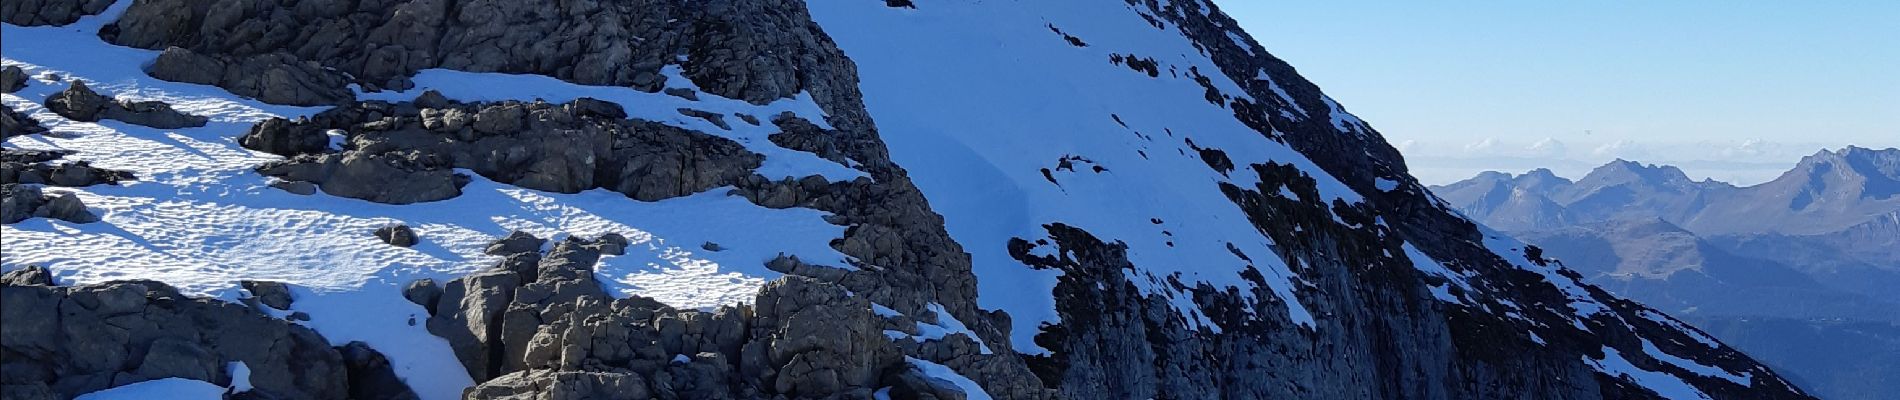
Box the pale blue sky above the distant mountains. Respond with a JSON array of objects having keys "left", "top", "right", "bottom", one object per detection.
[{"left": 1216, "top": 0, "right": 1900, "bottom": 184}]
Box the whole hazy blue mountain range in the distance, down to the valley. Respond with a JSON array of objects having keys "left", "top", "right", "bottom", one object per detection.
[{"left": 1431, "top": 146, "right": 1900, "bottom": 398}]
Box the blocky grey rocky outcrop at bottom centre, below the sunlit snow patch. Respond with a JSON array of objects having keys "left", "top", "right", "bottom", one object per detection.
[{"left": 410, "top": 233, "right": 980, "bottom": 398}]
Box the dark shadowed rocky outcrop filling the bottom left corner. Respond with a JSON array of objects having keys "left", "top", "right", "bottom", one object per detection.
[{"left": 0, "top": 278, "right": 414, "bottom": 400}]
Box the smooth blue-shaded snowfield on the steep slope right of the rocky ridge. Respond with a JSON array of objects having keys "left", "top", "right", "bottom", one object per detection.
[{"left": 809, "top": 2, "right": 1362, "bottom": 353}]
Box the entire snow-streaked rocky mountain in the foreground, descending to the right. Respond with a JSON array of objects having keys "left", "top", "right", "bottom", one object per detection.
[{"left": 0, "top": 0, "right": 1809, "bottom": 398}]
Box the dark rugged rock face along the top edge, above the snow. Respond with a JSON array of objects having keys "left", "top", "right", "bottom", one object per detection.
[{"left": 101, "top": 0, "right": 862, "bottom": 104}]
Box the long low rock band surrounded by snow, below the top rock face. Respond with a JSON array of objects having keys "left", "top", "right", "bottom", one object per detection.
[{"left": 239, "top": 93, "right": 764, "bottom": 203}]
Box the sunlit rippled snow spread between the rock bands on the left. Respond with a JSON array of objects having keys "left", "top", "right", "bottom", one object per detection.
[{"left": 0, "top": 2, "right": 861, "bottom": 400}]
